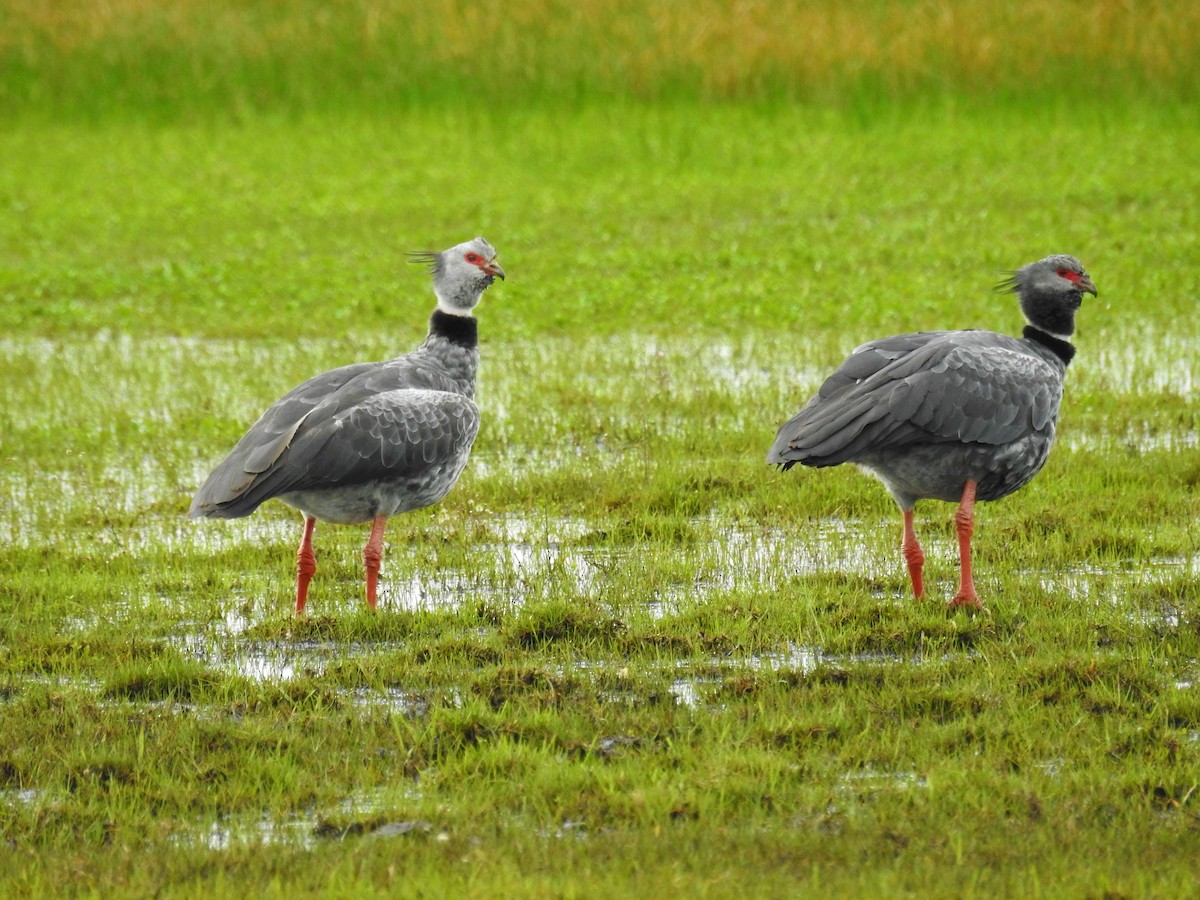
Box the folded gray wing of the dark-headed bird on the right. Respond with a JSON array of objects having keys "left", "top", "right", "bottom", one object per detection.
[{"left": 768, "top": 332, "right": 1062, "bottom": 466}]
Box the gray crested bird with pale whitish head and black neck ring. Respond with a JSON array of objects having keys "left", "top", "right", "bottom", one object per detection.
[{"left": 188, "top": 238, "right": 504, "bottom": 614}]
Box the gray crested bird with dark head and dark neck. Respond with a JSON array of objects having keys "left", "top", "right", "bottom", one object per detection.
[{"left": 767, "top": 254, "right": 1098, "bottom": 608}]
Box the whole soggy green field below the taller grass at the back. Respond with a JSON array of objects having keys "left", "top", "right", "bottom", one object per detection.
[{"left": 0, "top": 95, "right": 1200, "bottom": 896}]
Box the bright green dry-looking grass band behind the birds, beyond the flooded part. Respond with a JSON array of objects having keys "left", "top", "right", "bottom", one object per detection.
[{"left": 0, "top": 104, "right": 1198, "bottom": 345}]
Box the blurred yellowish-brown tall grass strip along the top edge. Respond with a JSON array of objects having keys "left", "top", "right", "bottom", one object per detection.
[{"left": 0, "top": 0, "right": 1200, "bottom": 96}]
